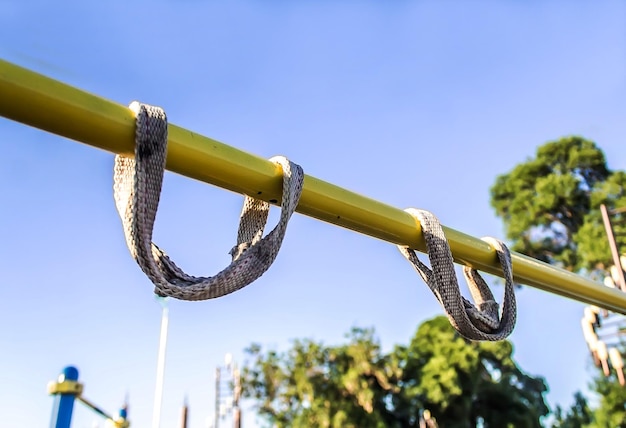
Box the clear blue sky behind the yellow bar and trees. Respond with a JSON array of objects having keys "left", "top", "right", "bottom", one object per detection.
[{"left": 0, "top": 0, "right": 626, "bottom": 428}]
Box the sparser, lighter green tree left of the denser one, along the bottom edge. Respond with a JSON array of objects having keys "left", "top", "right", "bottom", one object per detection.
[{"left": 242, "top": 328, "right": 396, "bottom": 428}]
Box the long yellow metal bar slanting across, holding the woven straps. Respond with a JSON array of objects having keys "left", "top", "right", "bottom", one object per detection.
[{"left": 0, "top": 60, "right": 626, "bottom": 314}]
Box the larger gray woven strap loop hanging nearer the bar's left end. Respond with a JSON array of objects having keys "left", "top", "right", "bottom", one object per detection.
[{"left": 113, "top": 102, "right": 304, "bottom": 300}]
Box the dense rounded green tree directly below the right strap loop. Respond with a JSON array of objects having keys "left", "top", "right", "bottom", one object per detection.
[{"left": 394, "top": 317, "right": 549, "bottom": 428}]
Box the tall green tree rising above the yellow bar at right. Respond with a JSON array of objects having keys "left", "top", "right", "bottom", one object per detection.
[{"left": 491, "top": 137, "right": 626, "bottom": 271}]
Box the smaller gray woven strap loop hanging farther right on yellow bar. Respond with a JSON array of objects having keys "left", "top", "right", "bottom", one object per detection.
[{"left": 398, "top": 208, "right": 517, "bottom": 340}]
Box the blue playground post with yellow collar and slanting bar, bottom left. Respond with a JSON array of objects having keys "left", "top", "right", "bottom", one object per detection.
[{"left": 48, "top": 366, "right": 130, "bottom": 428}]
